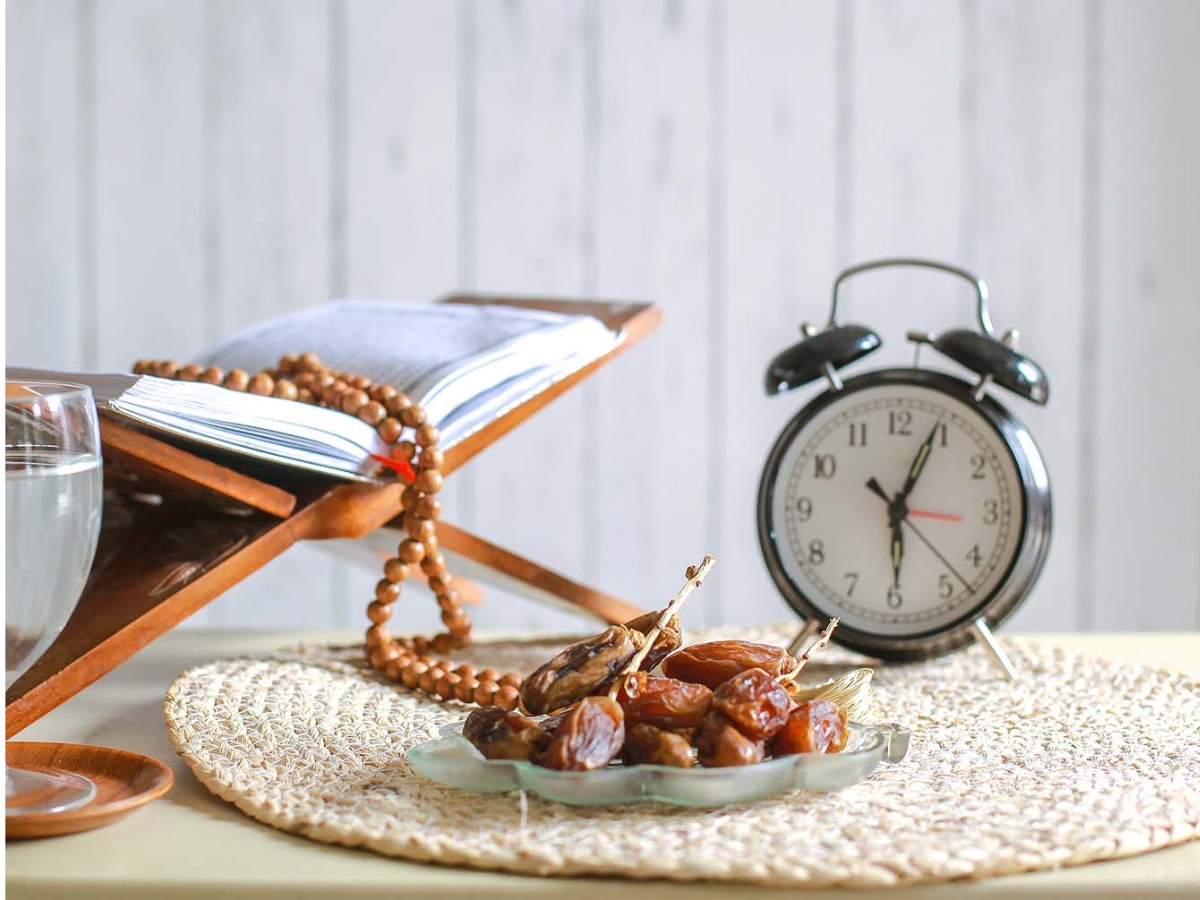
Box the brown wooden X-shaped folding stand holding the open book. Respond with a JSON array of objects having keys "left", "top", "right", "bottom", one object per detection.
[{"left": 5, "top": 296, "right": 661, "bottom": 737}]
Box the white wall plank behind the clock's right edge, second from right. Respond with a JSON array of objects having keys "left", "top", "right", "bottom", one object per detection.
[{"left": 961, "top": 0, "right": 1094, "bottom": 630}]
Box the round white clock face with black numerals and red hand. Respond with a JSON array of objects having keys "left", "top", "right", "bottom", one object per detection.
[{"left": 770, "top": 384, "right": 1025, "bottom": 637}]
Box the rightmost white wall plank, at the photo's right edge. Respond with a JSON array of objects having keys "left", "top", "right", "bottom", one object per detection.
[{"left": 1085, "top": 2, "right": 1200, "bottom": 629}]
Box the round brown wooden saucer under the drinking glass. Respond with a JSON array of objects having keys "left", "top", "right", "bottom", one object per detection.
[{"left": 5, "top": 740, "right": 175, "bottom": 840}]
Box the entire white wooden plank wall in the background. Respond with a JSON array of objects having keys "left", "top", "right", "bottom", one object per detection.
[{"left": 6, "top": 0, "right": 1200, "bottom": 630}]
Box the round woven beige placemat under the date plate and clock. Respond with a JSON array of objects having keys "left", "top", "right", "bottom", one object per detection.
[{"left": 164, "top": 626, "right": 1200, "bottom": 887}]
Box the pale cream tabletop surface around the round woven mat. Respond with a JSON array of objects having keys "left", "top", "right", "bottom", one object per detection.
[{"left": 5, "top": 631, "right": 1200, "bottom": 900}]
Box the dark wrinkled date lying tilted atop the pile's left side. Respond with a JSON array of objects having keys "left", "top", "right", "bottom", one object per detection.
[{"left": 521, "top": 625, "right": 646, "bottom": 715}]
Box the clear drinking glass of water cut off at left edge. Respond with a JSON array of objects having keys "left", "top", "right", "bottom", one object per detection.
[{"left": 4, "top": 380, "right": 103, "bottom": 816}]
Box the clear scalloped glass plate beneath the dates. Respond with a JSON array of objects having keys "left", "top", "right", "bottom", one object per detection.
[{"left": 408, "top": 722, "right": 911, "bottom": 806}]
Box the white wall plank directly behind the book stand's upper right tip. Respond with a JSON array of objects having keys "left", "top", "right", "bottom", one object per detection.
[{"left": 583, "top": 2, "right": 710, "bottom": 616}]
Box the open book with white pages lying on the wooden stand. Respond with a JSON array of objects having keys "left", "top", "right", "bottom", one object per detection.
[{"left": 7, "top": 300, "right": 622, "bottom": 480}]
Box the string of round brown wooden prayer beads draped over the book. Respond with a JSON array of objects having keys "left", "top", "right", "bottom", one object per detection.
[{"left": 133, "top": 353, "right": 522, "bottom": 709}]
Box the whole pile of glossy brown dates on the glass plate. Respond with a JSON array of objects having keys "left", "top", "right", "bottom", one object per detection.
[{"left": 462, "top": 613, "right": 847, "bottom": 772}]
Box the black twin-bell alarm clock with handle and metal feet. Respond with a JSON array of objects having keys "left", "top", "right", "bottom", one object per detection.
[{"left": 758, "top": 259, "right": 1051, "bottom": 678}]
